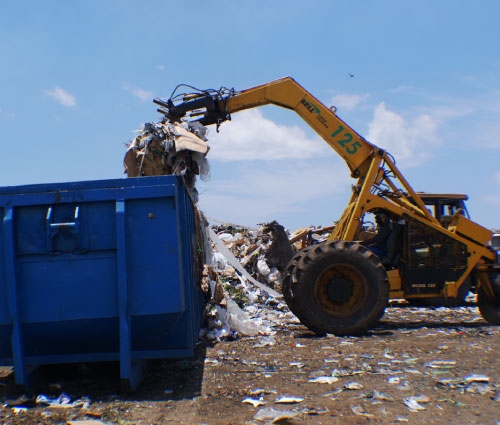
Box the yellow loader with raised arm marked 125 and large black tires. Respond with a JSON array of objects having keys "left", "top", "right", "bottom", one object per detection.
[{"left": 154, "top": 77, "right": 500, "bottom": 335}]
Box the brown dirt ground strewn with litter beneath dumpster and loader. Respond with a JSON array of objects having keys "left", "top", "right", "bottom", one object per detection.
[{"left": 0, "top": 304, "right": 500, "bottom": 425}]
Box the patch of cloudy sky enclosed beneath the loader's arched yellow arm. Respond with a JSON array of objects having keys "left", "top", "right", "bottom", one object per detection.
[{"left": 197, "top": 109, "right": 353, "bottom": 229}]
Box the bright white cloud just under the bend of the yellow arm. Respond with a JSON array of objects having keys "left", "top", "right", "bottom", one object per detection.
[{"left": 208, "top": 109, "right": 331, "bottom": 161}]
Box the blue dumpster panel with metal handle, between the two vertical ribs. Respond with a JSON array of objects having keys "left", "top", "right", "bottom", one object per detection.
[{"left": 14, "top": 200, "right": 118, "bottom": 363}]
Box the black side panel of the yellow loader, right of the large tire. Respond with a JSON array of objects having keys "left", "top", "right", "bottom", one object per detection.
[{"left": 400, "top": 215, "right": 468, "bottom": 295}]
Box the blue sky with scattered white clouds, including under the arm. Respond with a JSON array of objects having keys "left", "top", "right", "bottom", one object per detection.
[{"left": 0, "top": 0, "right": 500, "bottom": 229}]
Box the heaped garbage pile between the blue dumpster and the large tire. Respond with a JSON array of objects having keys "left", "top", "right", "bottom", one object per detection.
[{"left": 200, "top": 221, "right": 329, "bottom": 340}]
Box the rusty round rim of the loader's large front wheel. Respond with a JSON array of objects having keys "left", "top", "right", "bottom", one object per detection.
[{"left": 315, "top": 265, "right": 366, "bottom": 316}]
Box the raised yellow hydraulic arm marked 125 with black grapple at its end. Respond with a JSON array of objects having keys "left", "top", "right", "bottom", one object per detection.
[{"left": 155, "top": 77, "right": 438, "bottom": 230}]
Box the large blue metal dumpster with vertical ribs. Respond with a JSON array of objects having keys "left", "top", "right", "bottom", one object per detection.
[{"left": 0, "top": 176, "right": 204, "bottom": 388}]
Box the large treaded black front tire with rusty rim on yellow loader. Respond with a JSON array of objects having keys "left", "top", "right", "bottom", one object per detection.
[{"left": 291, "top": 241, "right": 389, "bottom": 336}]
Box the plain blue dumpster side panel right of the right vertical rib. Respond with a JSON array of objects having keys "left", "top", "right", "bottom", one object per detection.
[{"left": 126, "top": 198, "right": 187, "bottom": 352}]
